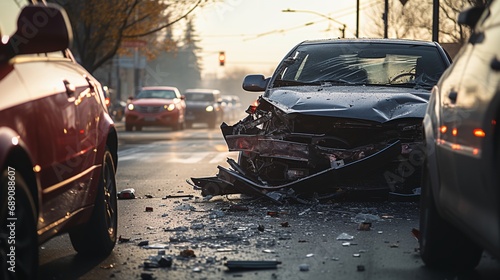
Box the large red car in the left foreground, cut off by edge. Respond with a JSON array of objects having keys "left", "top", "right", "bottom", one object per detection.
[{"left": 0, "top": 0, "right": 118, "bottom": 279}]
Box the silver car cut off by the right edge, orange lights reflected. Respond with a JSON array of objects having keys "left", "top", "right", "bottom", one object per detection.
[{"left": 420, "top": 0, "right": 500, "bottom": 269}]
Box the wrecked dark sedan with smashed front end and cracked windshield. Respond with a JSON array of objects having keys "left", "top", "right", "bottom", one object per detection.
[{"left": 192, "top": 39, "right": 451, "bottom": 202}]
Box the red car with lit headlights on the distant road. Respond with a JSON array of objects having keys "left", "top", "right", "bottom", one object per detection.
[{"left": 125, "top": 86, "right": 186, "bottom": 131}]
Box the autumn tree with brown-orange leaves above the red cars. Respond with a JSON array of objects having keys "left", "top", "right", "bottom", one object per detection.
[{"left": 52, "top": 0, "right": 208, "bottom": 72}]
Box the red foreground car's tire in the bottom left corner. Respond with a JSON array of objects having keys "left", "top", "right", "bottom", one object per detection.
[{"left": 0, "top": 168, "right": 38, "bottom": 279}]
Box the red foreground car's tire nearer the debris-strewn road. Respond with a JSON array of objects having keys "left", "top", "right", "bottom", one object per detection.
[{"left": 69, "top": 148, "right": 118, "bottom": 256}]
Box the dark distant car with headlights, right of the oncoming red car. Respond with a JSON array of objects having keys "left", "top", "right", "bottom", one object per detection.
[{"left": 184, "top": 89, "right": 224, "bottom": 128}]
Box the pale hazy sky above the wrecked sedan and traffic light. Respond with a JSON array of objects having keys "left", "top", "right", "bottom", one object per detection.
[{"left": 194, "top": 0, "right": 383, "bottom": 76}]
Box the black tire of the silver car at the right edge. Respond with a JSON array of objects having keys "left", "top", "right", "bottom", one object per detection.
[{"left": 419, "top": 163, "right": 483, "bottom": 270}]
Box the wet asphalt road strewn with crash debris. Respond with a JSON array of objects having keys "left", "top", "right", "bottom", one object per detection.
[{"left": 40, "top": 124, "right": 500, "bottom": 280}]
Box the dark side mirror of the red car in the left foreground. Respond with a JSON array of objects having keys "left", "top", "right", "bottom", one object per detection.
[{"left": 0, "top": 4, "right": 73, "bottom": 60}]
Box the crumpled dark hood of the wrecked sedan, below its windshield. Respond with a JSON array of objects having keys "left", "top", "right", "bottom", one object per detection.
[{"left": 263, "top": 86, "right": 430, "bottom": 123}]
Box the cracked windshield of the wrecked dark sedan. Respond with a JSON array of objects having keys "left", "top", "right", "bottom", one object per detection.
[{"left": 273, "top": 42, "right": 446, "bottom": 89}]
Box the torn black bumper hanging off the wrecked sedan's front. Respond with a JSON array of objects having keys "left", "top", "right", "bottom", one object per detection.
[{"left": 191, "top": 141, "right": 401, "bottom": 203}]
